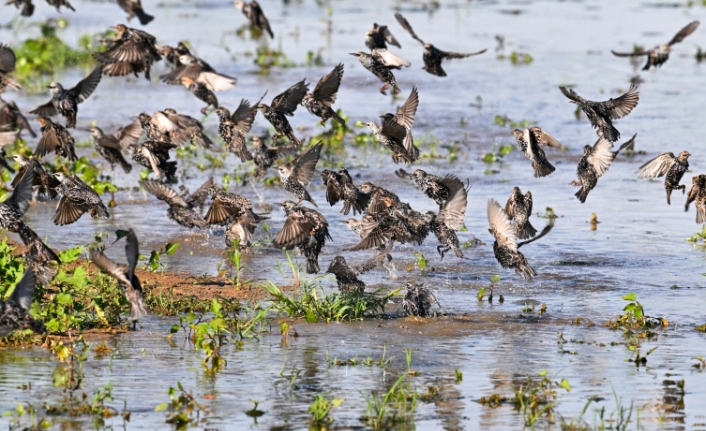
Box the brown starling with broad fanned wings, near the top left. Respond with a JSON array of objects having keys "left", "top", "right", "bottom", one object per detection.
[{"left": 93, "top": 24, "right": 162, "bottom": 81}]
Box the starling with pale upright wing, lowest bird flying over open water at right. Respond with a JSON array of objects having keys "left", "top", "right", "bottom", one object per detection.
[{"left": 488, "top": 199, "right": 554, "bottom": 281}]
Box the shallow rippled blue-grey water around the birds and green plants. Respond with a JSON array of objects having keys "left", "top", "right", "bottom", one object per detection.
[{"left": 0, "top": 0, "right": 706, "bottom": 430}]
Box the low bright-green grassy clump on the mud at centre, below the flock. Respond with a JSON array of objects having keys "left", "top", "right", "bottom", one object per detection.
[{"left": 261, "top": 281, "right": 397, "bottom": 323}]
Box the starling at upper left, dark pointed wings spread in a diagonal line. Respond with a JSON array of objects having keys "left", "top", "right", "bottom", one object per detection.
[{"left": 29, "top": 66, "right": 102, "bottom": 129}]
